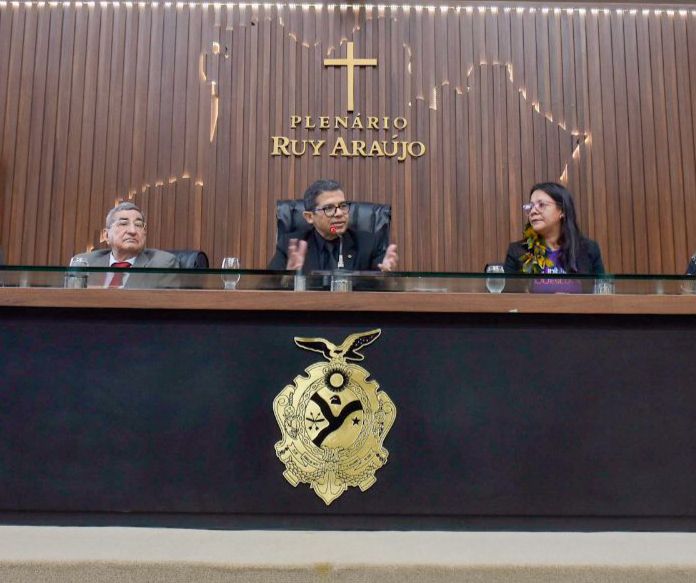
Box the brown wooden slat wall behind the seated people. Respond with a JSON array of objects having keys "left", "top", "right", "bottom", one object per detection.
[{"left": 0, "top": 1, "right": 696, "bottom": 273}]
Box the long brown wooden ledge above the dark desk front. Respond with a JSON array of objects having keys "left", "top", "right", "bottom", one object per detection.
[{"left": 0, "top": 288, "right": 696, "bottom": 315}]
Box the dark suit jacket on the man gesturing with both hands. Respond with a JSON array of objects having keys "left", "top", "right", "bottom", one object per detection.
[{"left": 268, "top": 227, "right": 384, "bottom": 274}]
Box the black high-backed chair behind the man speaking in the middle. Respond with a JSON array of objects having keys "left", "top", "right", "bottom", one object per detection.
[{"left": 276, "top": 200, "right": 391, "bottom": 253}]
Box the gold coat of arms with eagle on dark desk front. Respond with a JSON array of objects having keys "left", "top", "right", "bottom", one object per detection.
[{"left": 273, "top": 330, "right": 396, "bottom": 506}]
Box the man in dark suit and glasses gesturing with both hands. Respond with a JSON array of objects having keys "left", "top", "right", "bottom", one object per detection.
[{"left": 268, "top": 180, "right": 399, "bottom": 273}]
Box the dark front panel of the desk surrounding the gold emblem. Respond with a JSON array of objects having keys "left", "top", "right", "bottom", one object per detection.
[{"left": 0, "top": 308, "right": 696, "bottom": 527}]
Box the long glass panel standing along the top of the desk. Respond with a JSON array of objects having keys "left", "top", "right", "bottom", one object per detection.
[{"left": 0, "top": 266, "right": 696, "bottom": 295}]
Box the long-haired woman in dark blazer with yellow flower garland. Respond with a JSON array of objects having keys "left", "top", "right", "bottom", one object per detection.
[{"left": 505, "top": 182, "right": 604, "bottom": 291}]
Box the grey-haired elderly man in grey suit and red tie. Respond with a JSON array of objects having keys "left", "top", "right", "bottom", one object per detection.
[{"left": 78, "top": 202, "right": 180, "bottom": 287}]
